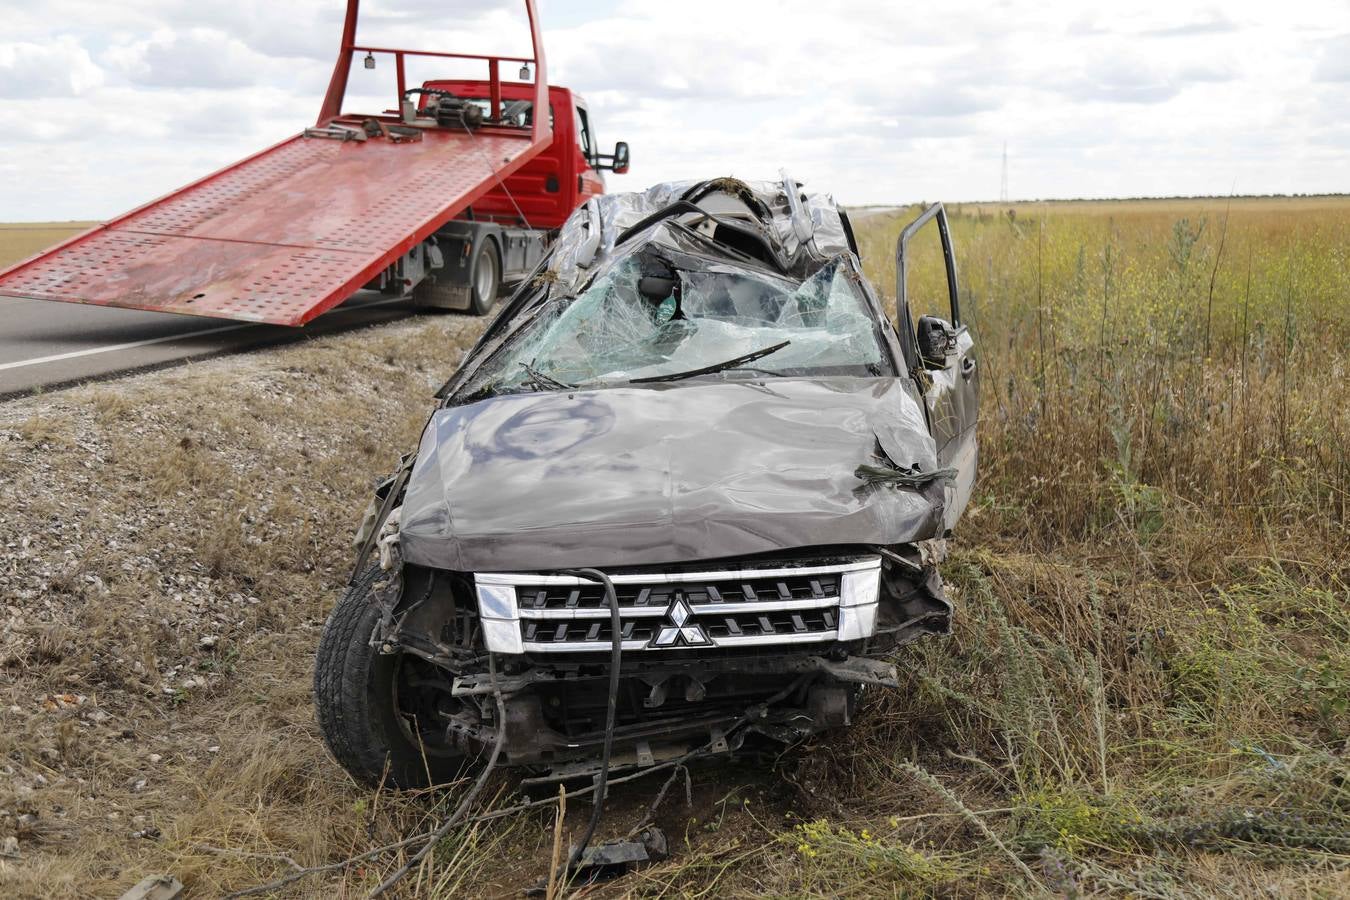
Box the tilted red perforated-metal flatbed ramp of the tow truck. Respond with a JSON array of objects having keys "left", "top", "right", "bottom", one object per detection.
[{"left": 0, "top": 128, "right": 548, "bottom": 325}]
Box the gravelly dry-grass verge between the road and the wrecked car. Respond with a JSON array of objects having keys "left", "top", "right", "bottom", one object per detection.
[{"left": 0, "top": 317, "right": 509, "bottom": 896}]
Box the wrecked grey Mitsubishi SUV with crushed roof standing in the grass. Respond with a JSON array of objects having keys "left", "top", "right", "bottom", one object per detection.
[{"left": 315, "top": 178, "right": 977, "bottom": 787}]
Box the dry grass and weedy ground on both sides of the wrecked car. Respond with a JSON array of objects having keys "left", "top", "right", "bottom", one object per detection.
[{"left": 0, "top": 198, "right": 1350, "bottom": 897}]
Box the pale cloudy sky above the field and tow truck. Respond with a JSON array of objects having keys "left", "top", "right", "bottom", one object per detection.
[{"left": 0, "top": 0, "right": 1350, "bottom": 221}]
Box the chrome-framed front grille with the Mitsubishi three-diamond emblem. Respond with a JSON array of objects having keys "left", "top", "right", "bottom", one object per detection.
[{"left": 475, "top": 557, "right": 880, "bottom": 653}]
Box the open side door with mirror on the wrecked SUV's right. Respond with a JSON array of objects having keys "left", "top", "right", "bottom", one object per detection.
[{"left": 895, "top": 204, "right": 980, "bottom": 529}]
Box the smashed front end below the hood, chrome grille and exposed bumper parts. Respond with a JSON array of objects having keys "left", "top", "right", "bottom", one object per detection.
[{"left": 378, "top": 542, "right": 952, "bottom": 777}]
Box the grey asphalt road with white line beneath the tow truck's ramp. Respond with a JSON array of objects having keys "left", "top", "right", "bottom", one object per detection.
[{"left": 0, "top": 291, "right": 413, "bottom": 398}]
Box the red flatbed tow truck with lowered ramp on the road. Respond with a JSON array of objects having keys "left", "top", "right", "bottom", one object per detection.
[{"left": 0, "top": 0, "right": 629, "bottom": 325}]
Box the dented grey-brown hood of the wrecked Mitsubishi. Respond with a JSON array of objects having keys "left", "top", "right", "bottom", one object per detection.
[{"left": 400, "top": 378, "right": 944, "bottom": 572}]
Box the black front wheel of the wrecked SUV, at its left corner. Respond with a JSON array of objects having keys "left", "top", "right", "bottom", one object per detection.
[{"left": 315, "top": 565, "right": 464, "bottom": 788}]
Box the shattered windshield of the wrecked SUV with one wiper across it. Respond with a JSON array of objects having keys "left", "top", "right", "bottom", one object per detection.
[{"left": 470, "top": 254, "right": 890, "bottom": 394}]
